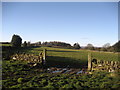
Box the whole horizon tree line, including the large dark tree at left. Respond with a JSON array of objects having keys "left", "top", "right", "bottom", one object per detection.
[{"left": 1, "top": 34, "right": 120, "bottom": 52}]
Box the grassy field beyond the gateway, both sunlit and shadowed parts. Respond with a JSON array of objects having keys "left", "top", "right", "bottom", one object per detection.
[{"left": 18, "top": 47, "right": 120, "bottom": 68}]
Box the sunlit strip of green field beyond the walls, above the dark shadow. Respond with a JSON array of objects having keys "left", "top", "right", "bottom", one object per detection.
[{"left": 23, "top": 47, "right": 120, "bottom": 61}]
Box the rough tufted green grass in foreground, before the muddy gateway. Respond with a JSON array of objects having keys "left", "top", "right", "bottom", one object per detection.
[{"left": 2, "top": 60, "right": 120, "bottom": 90}]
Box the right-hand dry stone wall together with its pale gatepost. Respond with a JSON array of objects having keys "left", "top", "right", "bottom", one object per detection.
[{"left": 88, "top": 53, "right": 120, "bottom": 72}]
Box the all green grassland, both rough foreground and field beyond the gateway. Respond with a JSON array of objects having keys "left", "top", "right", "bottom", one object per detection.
[{"left": 2, "top": 47, "right": 120, "bottom": 89}]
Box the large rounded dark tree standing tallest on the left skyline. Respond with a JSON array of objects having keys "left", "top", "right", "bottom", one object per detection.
[{"left": 11, "top": 34, "right": 22, "bottom": 47}]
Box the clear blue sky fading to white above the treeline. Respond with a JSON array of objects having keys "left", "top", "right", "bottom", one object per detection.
[{"left": 2, "top": 2, "right": 118, "bottom": 46}]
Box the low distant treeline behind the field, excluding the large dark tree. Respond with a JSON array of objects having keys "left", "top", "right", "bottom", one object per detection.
[{"left": 31, "top": 41, "right": 120, "bottom": 52}]
